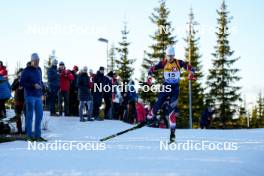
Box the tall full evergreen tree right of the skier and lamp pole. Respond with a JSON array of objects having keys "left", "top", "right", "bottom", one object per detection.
[{"left": 207, "top": 1, "right": 241, "bottom": 127}]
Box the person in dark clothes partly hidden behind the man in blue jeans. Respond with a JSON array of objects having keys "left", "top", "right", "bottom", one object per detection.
[{"left": 10, "top": 68, "right": 26, "bottom": 134}]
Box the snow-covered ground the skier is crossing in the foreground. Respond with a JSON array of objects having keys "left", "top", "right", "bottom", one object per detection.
[{"left": 0, "top": 112, "right": 264, "bottom": 176}]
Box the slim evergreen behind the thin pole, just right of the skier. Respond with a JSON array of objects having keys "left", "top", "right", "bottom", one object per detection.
[{"left": 177, "top": 9, "right": 204, "bottom": 128}]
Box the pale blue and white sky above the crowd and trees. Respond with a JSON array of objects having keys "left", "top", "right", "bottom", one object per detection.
[{"left": 0, "top": 0, "right": 264, "bottom": 105}]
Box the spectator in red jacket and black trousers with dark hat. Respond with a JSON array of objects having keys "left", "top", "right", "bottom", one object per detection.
[{"left": 58, "top": 62, "right": 74, "bottom": 116}]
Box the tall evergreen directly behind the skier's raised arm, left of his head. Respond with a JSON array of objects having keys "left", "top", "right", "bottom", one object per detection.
[{"left": 140, "top": 0, "right": 176, "bottom": 104}]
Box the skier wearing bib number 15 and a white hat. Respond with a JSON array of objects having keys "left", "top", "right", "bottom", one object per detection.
[{"left": 147, "top": 47, "right": 195, "bottom": 143}]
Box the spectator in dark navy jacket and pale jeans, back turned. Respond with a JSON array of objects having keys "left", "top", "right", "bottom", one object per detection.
[{"left": 78, "top": 67, "right": 94, "bottom": 122}]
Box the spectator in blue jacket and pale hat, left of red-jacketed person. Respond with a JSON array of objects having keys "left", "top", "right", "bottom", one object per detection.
[{"left": 48, "top": 59, "right": 60, "bottom": 116}]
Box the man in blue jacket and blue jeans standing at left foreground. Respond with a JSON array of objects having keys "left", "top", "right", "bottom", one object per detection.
[{"left": 20, "top": 53, "right": 45, "bottom": 141}]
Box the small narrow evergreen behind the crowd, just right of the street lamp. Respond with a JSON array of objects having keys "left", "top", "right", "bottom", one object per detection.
[{"left": 116, "top": 23, "right": 135, "bottom": 82}]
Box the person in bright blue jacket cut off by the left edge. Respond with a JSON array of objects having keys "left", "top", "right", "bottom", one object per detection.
[{"left": 0, "top": 76, "right": 11, "bottom": 119}]
